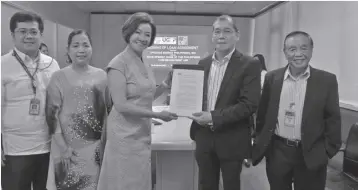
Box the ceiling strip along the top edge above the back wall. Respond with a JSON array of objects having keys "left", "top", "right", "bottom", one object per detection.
[{"left": 68, "top": 1, "right": 279, "bottom": 16}]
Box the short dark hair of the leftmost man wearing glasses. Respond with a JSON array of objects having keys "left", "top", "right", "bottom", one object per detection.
[{"left": 10, "top": 11, "right": 44, "bottom": 33}]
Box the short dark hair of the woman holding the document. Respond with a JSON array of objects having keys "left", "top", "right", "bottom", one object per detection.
[{"left": 122, "top": 12, "right": 157, "bottom": 46}]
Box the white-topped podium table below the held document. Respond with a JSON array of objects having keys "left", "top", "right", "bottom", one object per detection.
[{"left": 152, "top": 114, "right": 198, "bottom": 190}]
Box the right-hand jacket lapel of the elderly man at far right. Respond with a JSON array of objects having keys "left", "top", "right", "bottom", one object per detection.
[{"left": 301, "top": 66, "right": 318, "bottom": 130}]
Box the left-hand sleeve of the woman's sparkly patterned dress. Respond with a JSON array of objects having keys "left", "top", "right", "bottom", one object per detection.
[{"left": 45, "top": 71, "right": 62, "bottom": 134}]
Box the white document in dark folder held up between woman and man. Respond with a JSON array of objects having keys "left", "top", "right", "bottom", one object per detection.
[{"left": 170, "top": 65, "right": 204, "bottom": 117}]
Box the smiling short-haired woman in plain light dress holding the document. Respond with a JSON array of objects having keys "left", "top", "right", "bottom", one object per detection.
[{"left": 98, "top": 13, "right": 177, "bottom": 190}]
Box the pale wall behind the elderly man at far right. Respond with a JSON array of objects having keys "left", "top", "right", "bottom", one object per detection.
[{"left": 254, "top": 2, "right": 358, "bottom": 111}]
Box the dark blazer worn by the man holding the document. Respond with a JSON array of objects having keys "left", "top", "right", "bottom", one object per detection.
[{"left": 190, "top": 50, "right": 261, "bottom": 158}]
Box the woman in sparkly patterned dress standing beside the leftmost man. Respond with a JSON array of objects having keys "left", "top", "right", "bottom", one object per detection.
[{"left": 46, "top": 30, "right": 107, "bottom": 190}]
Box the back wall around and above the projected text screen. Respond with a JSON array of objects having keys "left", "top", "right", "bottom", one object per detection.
[{"left": 90, "top": 14, "right": 253, "bottom": 71}]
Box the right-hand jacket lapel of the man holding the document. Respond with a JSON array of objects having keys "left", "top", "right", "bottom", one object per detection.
[{"left": 215, "top": 50, "right": 242, "bottom": 107}]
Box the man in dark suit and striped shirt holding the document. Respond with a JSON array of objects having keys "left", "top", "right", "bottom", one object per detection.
[{"left": 190, "top": 15, "right": 261, "bottom": 190}]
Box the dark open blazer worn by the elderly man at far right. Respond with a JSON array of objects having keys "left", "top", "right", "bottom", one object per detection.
[{"left": 252, "top": 66, "right": 342, "bottom": 168}]
